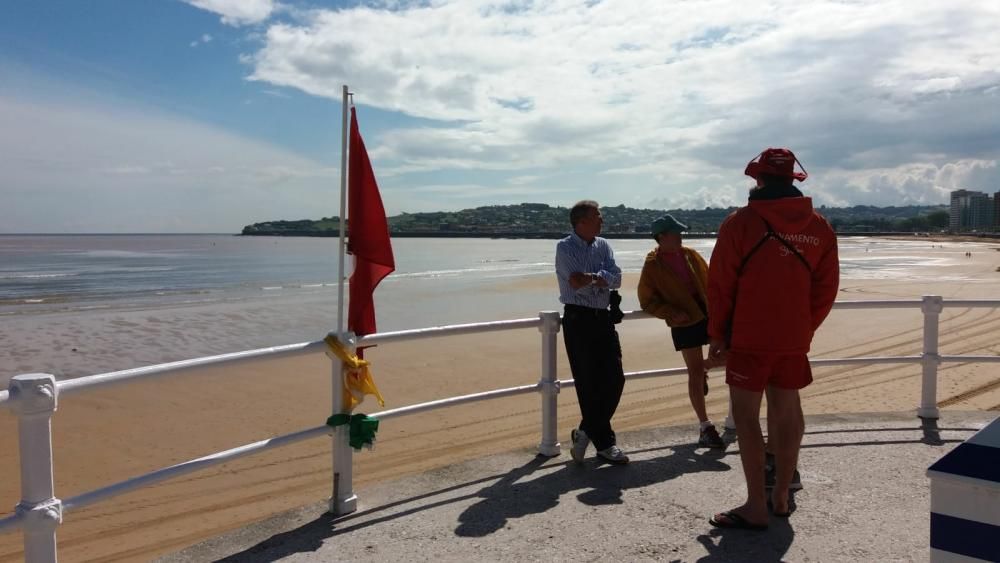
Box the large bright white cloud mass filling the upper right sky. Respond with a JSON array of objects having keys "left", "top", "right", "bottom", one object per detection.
[{"left": 245, "top": 0, "right": 1000, "bottom": 209}]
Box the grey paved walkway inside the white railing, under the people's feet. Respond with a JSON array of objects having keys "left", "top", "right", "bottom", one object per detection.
[{"left": 163, "top": 412, "right": 1000, "bottom": 562}]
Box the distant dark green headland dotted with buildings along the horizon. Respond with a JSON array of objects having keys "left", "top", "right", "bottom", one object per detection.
[{"left": 241, "top": 203, "right": 948, "bottom": 239}]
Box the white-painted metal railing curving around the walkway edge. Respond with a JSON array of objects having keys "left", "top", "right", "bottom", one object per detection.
[{"left": 0, "top": 295, "right": 1000, "bottom": 562}]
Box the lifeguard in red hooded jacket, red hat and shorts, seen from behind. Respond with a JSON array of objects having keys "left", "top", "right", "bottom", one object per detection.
[{"left": 708, "top": 149, "right": 840, "bottom": 530}]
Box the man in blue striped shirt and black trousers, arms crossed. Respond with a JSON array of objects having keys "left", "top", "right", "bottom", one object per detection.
[{"left": 556, "top": 200, "right": 628, "bottom": 465}]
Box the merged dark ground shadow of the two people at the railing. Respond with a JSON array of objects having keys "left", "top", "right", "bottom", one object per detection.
[{"left": 455, "top": 445, "right": 731, "bottom": 537}]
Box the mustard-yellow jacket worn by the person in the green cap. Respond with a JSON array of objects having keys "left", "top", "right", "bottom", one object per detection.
[{"left": 639, "top": 246, "right": 708, "bottom": 327}]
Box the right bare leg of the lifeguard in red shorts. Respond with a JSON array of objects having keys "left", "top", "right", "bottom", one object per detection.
[{"left": 764, "top": 387, "right": 805, "bottom": 512}]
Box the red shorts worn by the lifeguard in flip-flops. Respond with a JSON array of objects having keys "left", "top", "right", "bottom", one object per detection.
[{"left": 726, "top": 352, "right": 812, "bottom": 393}]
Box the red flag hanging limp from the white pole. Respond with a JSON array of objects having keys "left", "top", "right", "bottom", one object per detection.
[{"left": 347, "top": 107, "right": 396, "bottom": 336}]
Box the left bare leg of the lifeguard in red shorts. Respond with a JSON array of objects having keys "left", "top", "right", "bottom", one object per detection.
[{"left": 729, "top": 385, "right": 767, "bottom": 524}]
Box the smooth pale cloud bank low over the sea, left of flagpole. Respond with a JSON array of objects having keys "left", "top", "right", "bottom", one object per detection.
[{"left": 0, "top": 95, "right": 340, "bottom": 232}]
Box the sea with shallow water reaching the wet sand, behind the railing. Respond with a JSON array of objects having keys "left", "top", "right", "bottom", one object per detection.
[{"left": 0, "top": 234, "right": 984, "bottom": 385}]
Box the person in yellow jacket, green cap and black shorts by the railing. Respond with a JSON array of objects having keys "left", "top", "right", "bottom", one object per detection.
[{"left": 639, "top": 215, "right": 726, "bottom": 448}]
